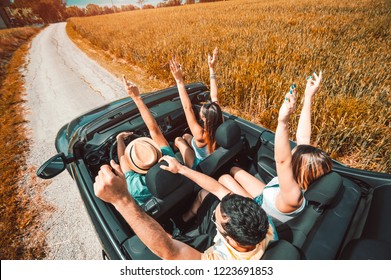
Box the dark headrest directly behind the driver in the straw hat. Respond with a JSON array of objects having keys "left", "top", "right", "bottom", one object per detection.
[{"left": 145, "top": 161, "right": 183, "bottom": 199}]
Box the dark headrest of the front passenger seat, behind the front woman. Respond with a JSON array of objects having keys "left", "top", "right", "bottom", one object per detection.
[{"left": 216, "top": 120, "right": 241, "bottom": 149}]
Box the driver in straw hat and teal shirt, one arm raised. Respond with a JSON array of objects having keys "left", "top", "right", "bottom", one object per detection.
[{"left": 111, "top": 75, "right": 175, "bottom": 205}]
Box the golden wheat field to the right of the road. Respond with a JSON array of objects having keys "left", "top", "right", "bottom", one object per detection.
[{"left": 68, "top": 0, "right": 391, "bottom": 173}]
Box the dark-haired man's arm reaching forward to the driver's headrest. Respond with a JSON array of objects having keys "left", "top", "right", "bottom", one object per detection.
[{"left": 160, "top": 156, "right": 230, "bottom": 200}]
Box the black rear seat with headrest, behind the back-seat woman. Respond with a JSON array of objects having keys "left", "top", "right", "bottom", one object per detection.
[{"left": 277, "top": 172, "right": 361, "bottom": 260}]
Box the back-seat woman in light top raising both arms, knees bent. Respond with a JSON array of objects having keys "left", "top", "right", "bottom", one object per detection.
[{"left": 219, "top": 72, "right": 332, "bottom": 223}]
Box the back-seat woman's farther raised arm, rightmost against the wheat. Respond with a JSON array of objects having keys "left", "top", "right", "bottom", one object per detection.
[{"left": 296, "top": 71, "right": 322, "bottom": 145}]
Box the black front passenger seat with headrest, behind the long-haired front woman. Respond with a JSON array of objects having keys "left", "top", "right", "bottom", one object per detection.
[{"left": 197, "top": 120, "right": 243, "bottom": 176}]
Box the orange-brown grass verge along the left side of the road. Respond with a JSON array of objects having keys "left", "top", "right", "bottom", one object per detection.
[{"left": 0, "top": 27, "right": 51, "bottom": 260}]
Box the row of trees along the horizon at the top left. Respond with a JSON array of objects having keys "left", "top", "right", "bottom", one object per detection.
[{"left": 9, "top": 0, "right": 224, "bottom": 27}]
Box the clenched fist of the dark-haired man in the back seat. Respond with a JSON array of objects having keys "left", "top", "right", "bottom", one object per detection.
[{"left": 94, "top": 161, "right": 130, "bottom": 205}]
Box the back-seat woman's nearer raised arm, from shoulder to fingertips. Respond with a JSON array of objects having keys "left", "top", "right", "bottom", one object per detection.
[{"left": 274, "top": 92, "right": 301, "bottom": 212}]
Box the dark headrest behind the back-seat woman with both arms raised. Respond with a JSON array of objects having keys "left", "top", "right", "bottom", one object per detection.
[{"left": 304, "top": 172, "right": 342, "bottom": 207}]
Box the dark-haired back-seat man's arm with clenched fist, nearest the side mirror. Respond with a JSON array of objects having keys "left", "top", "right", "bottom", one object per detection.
[{"left": 94, "top": 165, "right": 201, "bottom": 260}]
